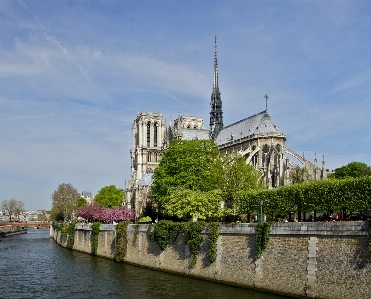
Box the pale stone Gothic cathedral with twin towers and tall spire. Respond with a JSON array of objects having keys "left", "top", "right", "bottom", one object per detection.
[{"left": 126, "top": 39, "right": 326, "bottom": 217}]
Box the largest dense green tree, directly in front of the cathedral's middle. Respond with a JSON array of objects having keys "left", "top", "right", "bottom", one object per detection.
[{"left": 152, "top": 139, "right": 221, "bottom": 208}]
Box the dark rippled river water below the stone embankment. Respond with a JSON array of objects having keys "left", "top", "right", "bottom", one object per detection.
[{"left": 0, "top": 229, "right": 286, "bottom": 299}]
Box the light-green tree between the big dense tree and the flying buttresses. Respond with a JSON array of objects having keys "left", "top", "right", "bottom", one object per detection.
[{"left": 221, "top": 153, "right": 266, "bottom": 213}]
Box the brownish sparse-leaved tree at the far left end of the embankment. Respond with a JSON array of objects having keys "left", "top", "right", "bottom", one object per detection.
[{"left": 50, "top": 183, "right": 80, "bottom": 220}]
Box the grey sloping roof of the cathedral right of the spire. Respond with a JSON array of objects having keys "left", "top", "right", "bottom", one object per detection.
[{"left": 215, "top": 111, "right": 286, "bottom": 146}]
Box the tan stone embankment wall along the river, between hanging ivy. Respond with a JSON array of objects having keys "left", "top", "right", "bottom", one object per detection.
[{"left": 51, "top": 222, "right": 371, "bottom": 299}]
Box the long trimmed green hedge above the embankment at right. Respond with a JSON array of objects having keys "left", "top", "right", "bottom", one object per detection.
[{"left": 235, "top": 176, "right": 371, "bottom": 215}]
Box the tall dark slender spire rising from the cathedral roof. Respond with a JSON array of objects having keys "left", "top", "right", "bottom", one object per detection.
[{"left": 210, "top": 36, "right": 223, "bottom": 139}]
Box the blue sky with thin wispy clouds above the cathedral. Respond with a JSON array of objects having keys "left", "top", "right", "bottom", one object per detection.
[{"left": 0, "top": 0, "right": 371, "bottom": 210}]
